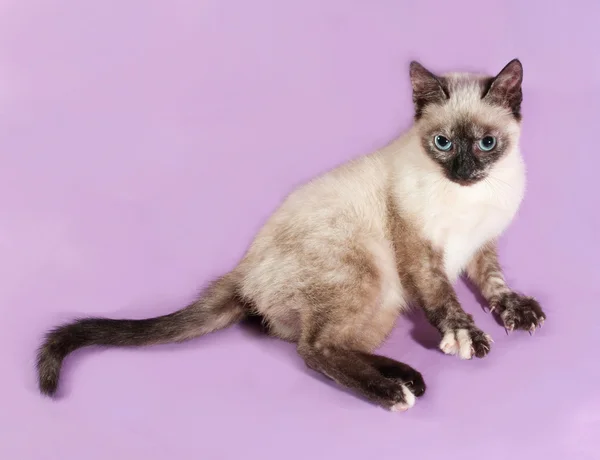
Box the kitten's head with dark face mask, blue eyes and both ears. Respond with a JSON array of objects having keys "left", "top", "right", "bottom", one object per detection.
[{"left": 410, "top": 59, "right": 523, "bottom": 185}]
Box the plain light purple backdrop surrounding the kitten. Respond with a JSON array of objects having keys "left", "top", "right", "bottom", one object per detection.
[{"left": 0, "top": 0, "right": 600, "bottom": 460}]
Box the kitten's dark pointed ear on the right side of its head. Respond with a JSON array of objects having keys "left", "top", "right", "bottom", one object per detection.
[{"left": 483, "top": 59, "right": 523, "bottom": 120}]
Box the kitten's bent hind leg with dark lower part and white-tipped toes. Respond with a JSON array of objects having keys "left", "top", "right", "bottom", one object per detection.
[{"left": 298, "top": 279, "right": 425, "bottom": 411}]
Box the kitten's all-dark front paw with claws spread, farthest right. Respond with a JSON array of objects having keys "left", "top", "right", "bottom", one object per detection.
[{"left": 490, "top": 292, "right": 546, "bottom": 333}]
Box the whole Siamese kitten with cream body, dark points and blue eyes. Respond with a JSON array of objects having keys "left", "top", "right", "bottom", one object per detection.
[{"left": 37, "top": 59, "right": 546, "bottom": 411}]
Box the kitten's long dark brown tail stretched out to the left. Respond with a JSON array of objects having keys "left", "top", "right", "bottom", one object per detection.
[{"left": 37, "top": 272, "right": 247, "bottom": 396}]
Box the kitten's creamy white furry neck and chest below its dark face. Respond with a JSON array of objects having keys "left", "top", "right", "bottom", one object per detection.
[{"left": 381, "top": 128, "right": 525, "bottom": 258}]
